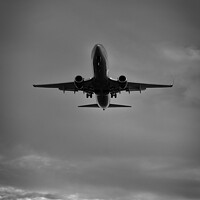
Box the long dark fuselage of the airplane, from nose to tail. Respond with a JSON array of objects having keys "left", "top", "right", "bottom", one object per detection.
[{"left": 91, "top": 44, "right": 110, "bottom": 109}]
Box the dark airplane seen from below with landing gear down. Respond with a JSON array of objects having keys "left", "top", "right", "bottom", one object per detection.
[{"left": 33, "top": 44, "right": 173, "bottom": 110}]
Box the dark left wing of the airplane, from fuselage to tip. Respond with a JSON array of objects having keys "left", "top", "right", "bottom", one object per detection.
[{"left": 33, "top": 79, "right": 93, "bottom": 93}]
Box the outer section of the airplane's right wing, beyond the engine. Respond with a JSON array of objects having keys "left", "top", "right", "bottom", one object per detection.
[{"left": 125, "top": 82, "right": 173, "bottom": 91}]
